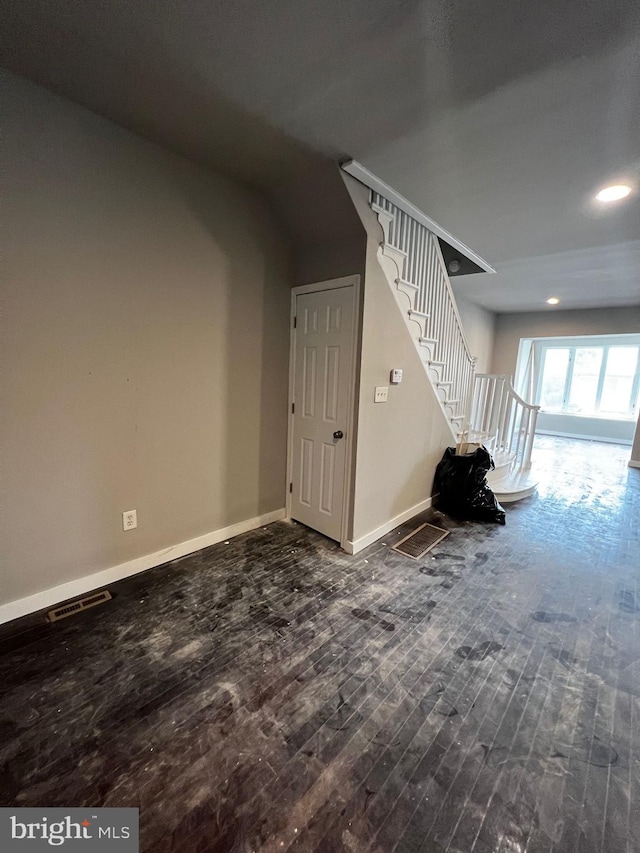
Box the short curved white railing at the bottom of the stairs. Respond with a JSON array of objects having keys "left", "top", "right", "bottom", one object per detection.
[{"left": 469, "top": 373, "right": 540, "bottom": 472}]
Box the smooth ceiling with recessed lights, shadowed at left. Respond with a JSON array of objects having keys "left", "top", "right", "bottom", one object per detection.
[{"left": 1, "top": 0, "right": 640, "bottom": 312}]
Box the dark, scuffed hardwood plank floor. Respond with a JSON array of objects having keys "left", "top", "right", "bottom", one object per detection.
[{"left": 0, "top": 438, "right": 640, "bottom": 853}]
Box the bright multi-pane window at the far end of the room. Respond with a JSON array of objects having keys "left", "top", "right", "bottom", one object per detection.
[{"left": 537, "top": 338, "right": 640, "bottom": 420}]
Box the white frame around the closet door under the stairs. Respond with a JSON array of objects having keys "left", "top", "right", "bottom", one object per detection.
[{"left": 286, "top": 275, "right": 360, "bottom": 551}]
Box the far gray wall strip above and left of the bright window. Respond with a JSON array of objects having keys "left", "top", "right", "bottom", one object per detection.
[{"left": 492, "top": 306, "right": 640, "bottom": 375}]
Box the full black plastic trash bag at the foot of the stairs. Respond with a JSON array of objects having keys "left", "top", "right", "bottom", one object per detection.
[{"left": 433, "top": 447, "right": 505, "bottom": 524}]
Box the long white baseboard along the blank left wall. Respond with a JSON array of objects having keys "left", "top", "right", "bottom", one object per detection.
[{"left": 0, "top": 508, "right": 287, "bottom": 625}]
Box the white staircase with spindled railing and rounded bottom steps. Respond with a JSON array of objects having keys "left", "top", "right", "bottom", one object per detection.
[{"left": 369, "top": 190, "right": 539, "bottom": 503}]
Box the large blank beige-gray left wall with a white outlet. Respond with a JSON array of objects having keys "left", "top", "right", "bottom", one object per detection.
[{"left": 0, "top": 75, "right": 291, "bottom": 603}]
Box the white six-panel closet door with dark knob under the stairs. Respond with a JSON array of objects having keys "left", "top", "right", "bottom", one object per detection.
[{"left": 291, "top": 285, "right": 355, "bottom": 541}]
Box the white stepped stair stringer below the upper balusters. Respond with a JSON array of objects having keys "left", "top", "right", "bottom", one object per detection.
[{"left": 377, "top": 240, "right": 464, "bottom": 444}]
